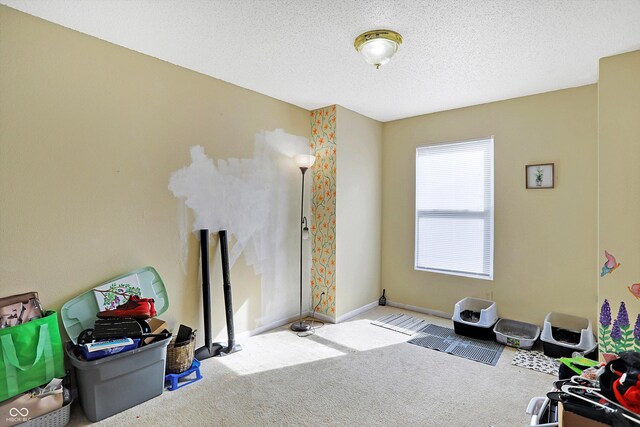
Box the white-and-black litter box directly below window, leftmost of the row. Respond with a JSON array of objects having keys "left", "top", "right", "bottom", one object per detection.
[{"left": 451, "top": 298, "right": 498, "bottom": 340}]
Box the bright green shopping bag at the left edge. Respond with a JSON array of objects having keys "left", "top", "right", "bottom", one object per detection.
[{"left": 0, "top": 311, "right": 65, "bottom": 401}]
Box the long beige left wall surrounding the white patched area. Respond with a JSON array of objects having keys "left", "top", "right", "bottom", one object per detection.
[{"left": 0, "top": 6, "right": 309, "bottom": 342}]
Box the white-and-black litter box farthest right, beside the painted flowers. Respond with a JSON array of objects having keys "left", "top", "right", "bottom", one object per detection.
[{"left": 540, "top": 312, "right": 596, "bottom": 358}]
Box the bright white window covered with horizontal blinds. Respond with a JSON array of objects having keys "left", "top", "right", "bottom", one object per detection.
[{"left": 415, "top": 137, "right": 493, "bottom": 280}]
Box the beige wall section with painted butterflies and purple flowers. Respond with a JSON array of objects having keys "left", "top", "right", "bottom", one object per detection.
[{"left": 598, "top": 50, "right": 640, "bottom": 353}]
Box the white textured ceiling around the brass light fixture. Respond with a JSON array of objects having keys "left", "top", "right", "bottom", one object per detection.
[{"left": 0, "top": 0, "right": 640, "bottom": 121}]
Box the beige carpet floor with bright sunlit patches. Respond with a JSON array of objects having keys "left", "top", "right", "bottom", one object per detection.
[{"left": 70, "top": 306, "right": 553, "bottom": 427}]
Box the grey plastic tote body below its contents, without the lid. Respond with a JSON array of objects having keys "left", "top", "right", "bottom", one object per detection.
[{"left": 66, "top": 338, "right": 171, "bottom": 422}]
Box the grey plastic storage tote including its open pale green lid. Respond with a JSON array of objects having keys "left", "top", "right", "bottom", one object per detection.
[{"left": 61, "top": 267, "right": 171, "bottom": 421}]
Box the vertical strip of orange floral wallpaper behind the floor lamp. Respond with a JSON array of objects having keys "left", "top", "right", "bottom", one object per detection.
[{"left": 310, "top": 105, "right": 337, "bottom": 317}]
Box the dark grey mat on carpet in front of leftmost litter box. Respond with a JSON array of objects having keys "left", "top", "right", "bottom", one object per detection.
[{"left": 408, "top": 324, "right": 504, "bottom": 366}]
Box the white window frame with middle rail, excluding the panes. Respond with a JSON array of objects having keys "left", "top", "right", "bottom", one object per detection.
[{"left": 413, "top": 135, "right": 495, "bottom": 280}]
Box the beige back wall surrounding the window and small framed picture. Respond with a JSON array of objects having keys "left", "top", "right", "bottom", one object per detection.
[{"left": 382, "top": 85, "right": 598, "bottom": 324}]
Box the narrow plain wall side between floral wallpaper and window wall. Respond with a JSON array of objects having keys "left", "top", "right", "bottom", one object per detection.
[{"left": 336, "top": 106, "right": 383, "bottom": 319}]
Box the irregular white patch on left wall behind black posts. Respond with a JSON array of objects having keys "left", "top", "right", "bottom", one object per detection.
[{"left": 169, "top": 129, "right": 309, "bottom": 323}]
